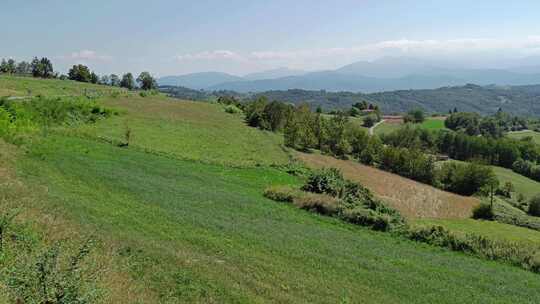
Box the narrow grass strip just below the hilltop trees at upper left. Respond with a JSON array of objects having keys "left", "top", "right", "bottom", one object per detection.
[{"left": 0, "top": 75, "right": 126, "bottom": 97}]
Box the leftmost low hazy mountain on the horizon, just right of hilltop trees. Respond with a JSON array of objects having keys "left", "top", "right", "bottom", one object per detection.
[{"left": 157, "top": 72, "right": 242, "bottom": 89}]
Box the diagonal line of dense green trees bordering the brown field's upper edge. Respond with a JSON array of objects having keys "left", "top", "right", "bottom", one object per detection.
[{"left": 219, "top": 97, "right": 498, "bottom": 195}]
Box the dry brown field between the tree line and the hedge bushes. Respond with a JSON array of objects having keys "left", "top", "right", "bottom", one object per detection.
[{"left": 298, "top": 153, "right": 480, "bottom": 219}]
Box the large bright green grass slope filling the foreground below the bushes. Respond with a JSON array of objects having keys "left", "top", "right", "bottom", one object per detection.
[{"left": 12, "top": 136, "right": 540, "bottom": 303}]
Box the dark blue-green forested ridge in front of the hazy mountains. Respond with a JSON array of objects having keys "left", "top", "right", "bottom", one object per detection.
[{"left": 162, "top": 84, "right": 540, "bottom": 116}]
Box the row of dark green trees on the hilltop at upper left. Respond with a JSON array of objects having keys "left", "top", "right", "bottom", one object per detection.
[{"left": 0, "top": 57, "right": 158, "bottom": 90}]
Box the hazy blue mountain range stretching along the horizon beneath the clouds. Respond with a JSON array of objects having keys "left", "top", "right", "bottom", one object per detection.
[{"left": 158, "top": 57, "right": 540, "bottom": 93}]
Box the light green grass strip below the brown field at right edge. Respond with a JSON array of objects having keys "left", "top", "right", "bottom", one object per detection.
[{"left": 414, "top": 219, "right": 540, "bottom": 248}]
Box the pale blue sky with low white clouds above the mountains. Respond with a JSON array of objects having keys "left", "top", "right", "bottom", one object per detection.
[{"left": 0, "top": 0, "right": 540, "bottom": 76}]
